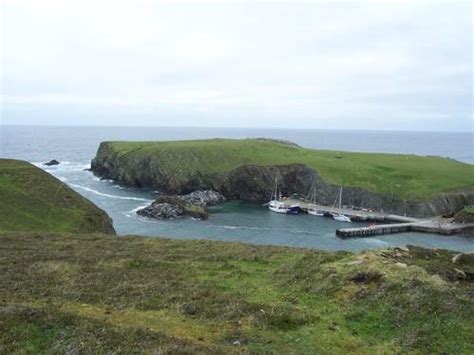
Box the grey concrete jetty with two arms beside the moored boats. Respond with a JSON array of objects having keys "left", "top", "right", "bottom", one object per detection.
[{"left": 284, "top": 199, "right": 474, "bottom": 238}]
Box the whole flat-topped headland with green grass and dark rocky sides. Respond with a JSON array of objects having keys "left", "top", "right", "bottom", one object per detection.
[{"left": 91, "top": 139, "right": 474, "bottom": 217}]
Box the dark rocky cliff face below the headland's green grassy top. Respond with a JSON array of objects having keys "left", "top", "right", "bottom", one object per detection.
[{"left": 91, "top": 144, "right": 474, "bottom": 217}]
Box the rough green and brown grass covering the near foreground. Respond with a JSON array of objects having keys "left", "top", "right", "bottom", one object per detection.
[{"left": 0, "top": 233, "right": 474, "bottom": 354}]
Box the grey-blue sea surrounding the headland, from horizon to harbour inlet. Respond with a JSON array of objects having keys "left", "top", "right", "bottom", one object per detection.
[{"left": 0, "top": 125, "right": 474, "bottom": 252}]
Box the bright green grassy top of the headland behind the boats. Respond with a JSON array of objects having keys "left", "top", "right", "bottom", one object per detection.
[{"left": 101, "top": 139, "right": 474, "bottom": 200}]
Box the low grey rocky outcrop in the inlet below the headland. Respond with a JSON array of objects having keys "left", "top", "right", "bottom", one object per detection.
[{"left": 137, "top": 190, "right": 227, "bottom": 219}]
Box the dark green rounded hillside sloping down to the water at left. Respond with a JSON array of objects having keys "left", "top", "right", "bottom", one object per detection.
[{"left": 0, "top": 159, "right": 114, "bottom": 233}]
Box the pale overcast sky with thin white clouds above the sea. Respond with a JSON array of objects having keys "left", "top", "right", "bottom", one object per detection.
[{"left": 0, "top": 0, "right": 474, "bottom": 132}]
